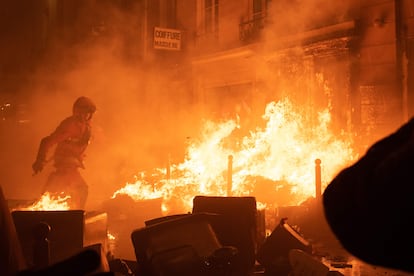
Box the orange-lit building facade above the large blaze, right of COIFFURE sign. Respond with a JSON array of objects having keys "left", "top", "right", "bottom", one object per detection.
[{"left": 178, "top": 0, "right": 414, "bottom": 147}]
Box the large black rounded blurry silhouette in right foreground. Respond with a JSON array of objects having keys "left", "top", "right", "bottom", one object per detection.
[{"left": 323, "top": 118, "right": 414, "bottom": 272}]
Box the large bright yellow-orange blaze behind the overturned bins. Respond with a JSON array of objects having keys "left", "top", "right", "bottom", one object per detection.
[{"left": 113, "top": 99, "right": 356, "bottom": 215}]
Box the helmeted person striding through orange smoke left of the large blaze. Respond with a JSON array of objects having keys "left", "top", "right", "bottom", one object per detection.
[{"left": 32, "top": 96, "right": 96, "bottom": 209}]
